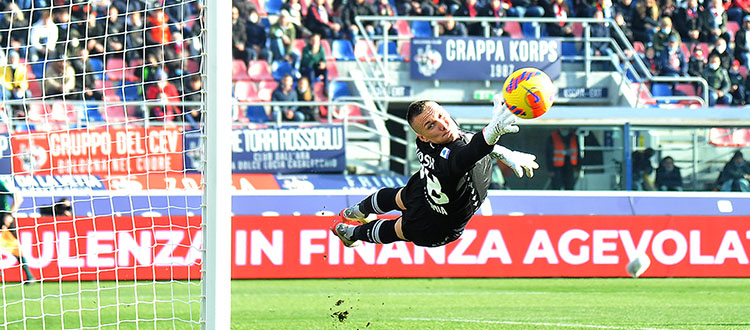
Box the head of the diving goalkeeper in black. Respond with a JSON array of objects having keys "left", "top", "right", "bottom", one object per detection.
[{"left": 411, "top": 102, "right": 459, "bottom": 144}]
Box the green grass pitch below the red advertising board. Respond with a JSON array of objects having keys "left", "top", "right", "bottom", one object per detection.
[{"left": 0, "top": 278, "right": 750, "bottom": 330}]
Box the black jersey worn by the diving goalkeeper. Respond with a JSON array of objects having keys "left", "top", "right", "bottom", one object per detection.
[{"left": 402, "top": 132, "right": 493, "bottom": 241}]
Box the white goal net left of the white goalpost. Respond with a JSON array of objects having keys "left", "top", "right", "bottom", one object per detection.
[{"left": 0, "top": 0, "right": 205, "bottom": 329}]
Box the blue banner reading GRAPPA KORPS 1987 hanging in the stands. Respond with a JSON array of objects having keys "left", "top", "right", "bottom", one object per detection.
[{"left": 411, "top": 37, "right": 562, "bottom": 81}]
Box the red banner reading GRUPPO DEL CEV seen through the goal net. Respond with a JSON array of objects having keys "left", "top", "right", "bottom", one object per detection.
[{"left": 11, "top": 127, "right": 183, "bottom": 175}]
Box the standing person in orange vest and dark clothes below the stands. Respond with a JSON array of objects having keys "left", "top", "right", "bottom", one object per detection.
[{"left": 546, "top": 128, "right": 581, "bottom": 190}]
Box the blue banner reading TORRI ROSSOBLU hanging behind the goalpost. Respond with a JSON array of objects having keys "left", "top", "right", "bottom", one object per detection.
[{"left": 184, "top": 125, "right": 346, "bottom": 173}]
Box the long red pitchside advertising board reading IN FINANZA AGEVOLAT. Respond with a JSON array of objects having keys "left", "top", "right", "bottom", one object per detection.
[{"left": 0, "top": 216, "right": 750, "bottom": 280}]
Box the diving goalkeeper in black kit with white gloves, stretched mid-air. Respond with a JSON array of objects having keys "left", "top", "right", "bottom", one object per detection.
[{"left": 331, "top": 95, "right": 539, "bottom": 247}]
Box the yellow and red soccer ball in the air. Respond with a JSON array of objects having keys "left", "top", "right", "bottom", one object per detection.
[{"left": 503, "top": 68, "right": 556, "bottom": 119}]
